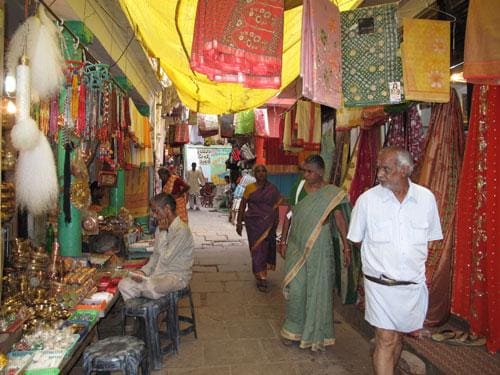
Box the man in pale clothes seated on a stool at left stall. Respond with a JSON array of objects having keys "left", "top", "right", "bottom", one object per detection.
[{"left": 118, "top": 193, "right": 194, "bottom": 301}]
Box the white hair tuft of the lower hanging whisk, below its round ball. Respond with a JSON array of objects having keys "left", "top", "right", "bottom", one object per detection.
[{"left": 15, "top": 134, "right": 59, "bottom": 215}]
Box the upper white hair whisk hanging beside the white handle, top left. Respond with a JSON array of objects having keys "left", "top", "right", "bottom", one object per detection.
[{"left": 28, "top": 6, "right": 65, "bottom": 99}]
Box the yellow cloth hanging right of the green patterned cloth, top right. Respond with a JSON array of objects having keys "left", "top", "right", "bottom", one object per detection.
[{"left": 401, "top": 18, "right": 450, "bottom": 103}]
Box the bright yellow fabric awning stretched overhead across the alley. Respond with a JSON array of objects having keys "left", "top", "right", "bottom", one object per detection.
[{"left": 120, "top": 0, "right": 358, "bottom": 114}]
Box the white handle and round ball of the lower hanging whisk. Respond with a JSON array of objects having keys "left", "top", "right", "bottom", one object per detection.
[{"left": 10, "top": 56, "right": 40, "bottom": 151}]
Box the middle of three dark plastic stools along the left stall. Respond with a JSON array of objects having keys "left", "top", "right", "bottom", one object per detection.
[{"left": 122, "top": 297, "right": 170, "bottom": 370}]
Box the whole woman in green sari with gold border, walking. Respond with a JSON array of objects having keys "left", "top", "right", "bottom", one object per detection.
[{"left": 278, "top": 155, "right": 351, "bottom": 350}]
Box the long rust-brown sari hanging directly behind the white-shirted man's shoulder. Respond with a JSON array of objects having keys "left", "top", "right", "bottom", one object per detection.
[{"left": 415, "top": 90, "right": 465, "bottom": 326}]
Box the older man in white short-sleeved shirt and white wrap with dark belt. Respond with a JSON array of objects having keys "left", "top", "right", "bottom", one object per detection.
[{"left": 347, "top": 147, "right": 443, "bottom": 375}]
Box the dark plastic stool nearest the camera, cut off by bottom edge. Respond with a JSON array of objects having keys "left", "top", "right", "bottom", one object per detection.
[{"left": 83, "top": 336, "right": 149, "bottom": 375}]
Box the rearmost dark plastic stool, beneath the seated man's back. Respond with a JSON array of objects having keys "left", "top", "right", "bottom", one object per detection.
[{"left": 162, "top": 286, "right": 198, "bottom": 354}]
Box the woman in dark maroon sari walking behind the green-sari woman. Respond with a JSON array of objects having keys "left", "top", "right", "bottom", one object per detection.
[{"left": 236, "top": 165, "right": 282, "bottom": 292}]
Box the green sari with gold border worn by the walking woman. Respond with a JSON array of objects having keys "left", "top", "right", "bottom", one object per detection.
[{"left": 281, "top": 185, "right": 347, "bottom": 350}]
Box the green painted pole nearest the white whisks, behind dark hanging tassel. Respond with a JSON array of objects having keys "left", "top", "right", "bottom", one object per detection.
[{"left": 57, "top": 130, "right": 82, "bottom": 257}]
